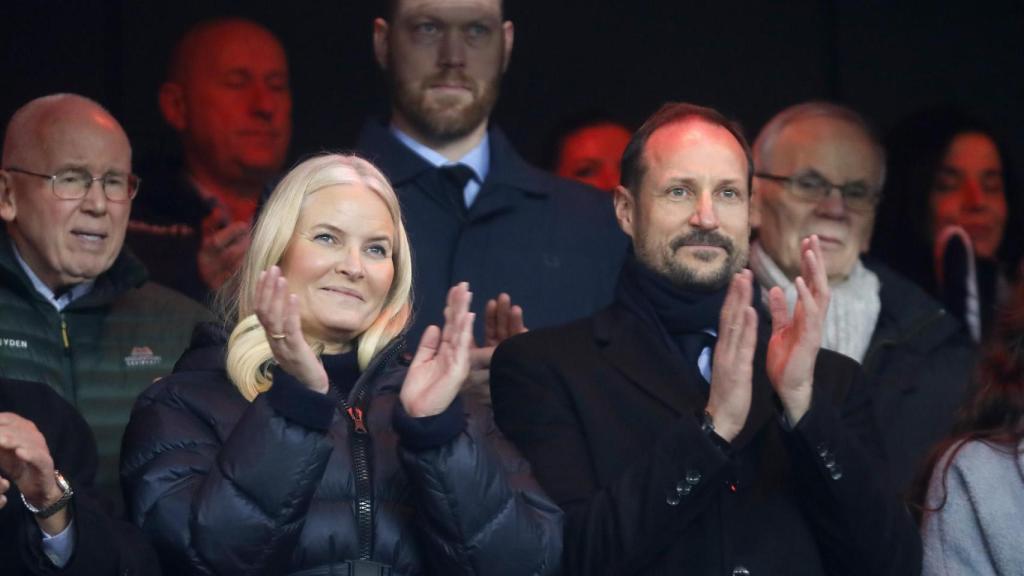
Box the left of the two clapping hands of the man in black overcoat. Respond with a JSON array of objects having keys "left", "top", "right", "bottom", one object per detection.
[{"left": 707, "top": 270, "right": 758, "bottom": 442}]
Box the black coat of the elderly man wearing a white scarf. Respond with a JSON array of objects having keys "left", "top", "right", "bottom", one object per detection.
[{"left": 863, "top": 259, "right": 976, "bottom": 492}]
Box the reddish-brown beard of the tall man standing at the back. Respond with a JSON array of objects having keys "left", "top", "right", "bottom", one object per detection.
[{"left": 389, "top": 68, "right": 502, "bottom": 142}]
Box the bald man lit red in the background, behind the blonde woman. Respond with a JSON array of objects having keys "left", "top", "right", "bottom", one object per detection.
[{"left": 128, "top": 18, "right": 292, "bottom": 301}]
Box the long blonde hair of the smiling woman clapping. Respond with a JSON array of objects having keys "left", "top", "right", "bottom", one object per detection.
[{"left": 218, "top": 154, "right": 413, "bottom": 401}]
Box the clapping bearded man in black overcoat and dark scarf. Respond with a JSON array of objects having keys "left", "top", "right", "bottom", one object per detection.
[{"left": 492, "top": 104, "right": 921, "bottom": 576}]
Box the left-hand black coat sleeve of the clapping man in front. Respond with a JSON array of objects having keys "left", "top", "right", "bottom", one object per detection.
[{"left": 490, "top": 339, "right": 728, "bottom": 576}]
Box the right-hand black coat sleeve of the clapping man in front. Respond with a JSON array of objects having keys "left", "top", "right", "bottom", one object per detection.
[{"left": 785, "top": 354, "right": 922, "bottom": 576}]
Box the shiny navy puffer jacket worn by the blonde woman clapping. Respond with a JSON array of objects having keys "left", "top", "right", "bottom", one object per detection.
[{"left": 122, "top": 325, "right": 562, "bottom": 576}]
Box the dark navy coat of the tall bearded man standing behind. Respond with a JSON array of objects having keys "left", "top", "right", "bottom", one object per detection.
[{"left": 356, "top": 120, "right": 626, "bottom": 342}]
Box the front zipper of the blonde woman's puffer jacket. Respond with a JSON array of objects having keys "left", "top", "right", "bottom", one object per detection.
[{"left": 342, "top": 341, "right": 403, "bottom": 561}]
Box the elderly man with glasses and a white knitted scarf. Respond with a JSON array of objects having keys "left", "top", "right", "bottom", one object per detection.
[{"left": 750, "top": 102, "right": 973, "bottom": 490}]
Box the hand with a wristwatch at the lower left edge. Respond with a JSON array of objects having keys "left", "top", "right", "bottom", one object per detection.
[{"left": 0, "top": 412, "right": 69, "bottom": 534}]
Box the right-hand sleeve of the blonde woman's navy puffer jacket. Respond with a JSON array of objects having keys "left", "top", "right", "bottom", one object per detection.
[{"left": 399, "top": 398, "right": 562, "bottom": 575}]
